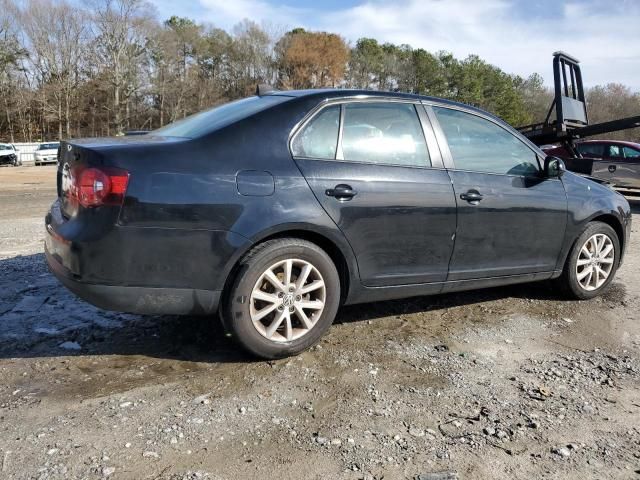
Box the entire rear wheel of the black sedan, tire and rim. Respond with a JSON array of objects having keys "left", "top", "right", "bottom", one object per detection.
[{"left": 223, "top": 238, "right": 340, "bottom": 359}]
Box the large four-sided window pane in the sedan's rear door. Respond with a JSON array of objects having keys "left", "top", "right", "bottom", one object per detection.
[{"left": 342, "top": 102, "right": 431, "bottom": 167}]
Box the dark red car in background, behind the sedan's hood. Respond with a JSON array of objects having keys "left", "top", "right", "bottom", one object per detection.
[{"left": 543, "top": 140, "right": 640, "bottom": 189}]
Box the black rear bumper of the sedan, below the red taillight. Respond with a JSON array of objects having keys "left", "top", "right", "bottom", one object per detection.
[{"left": 45, "top": 201, "right": 247, "bottom": 315}]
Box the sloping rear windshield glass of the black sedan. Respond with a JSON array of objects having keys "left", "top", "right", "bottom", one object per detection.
[{"left": 151, "top": 95, "right": 290, "bottom": 138}]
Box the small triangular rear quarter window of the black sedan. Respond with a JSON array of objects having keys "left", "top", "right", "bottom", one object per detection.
[{"left": 291, "top": 105, "right": 340, "bottom": 160}]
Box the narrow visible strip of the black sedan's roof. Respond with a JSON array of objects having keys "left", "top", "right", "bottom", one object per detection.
[{"left": 265, "top": 88, "right": 506, "bottom": 123}]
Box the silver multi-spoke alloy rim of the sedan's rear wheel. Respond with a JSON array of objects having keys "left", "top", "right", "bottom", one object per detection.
[{"left": 249, "top": 258, "right": 327, "bottom": 342}]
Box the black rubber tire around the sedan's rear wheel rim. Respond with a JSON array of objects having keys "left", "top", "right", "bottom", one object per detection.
[{"left": 222, "top": 238, "right": 340, "bottom": 359}]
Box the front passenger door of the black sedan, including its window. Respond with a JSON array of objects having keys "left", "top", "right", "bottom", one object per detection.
[{"left": 427, "top": 105, "right": 567, "bottom": 281}]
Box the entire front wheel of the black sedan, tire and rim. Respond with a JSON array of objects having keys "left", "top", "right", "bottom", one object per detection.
[{"left": 562, "top": 222, "right": 620, "bottom": 300}]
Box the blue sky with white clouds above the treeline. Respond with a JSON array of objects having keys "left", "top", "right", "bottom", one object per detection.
[{"left": 152, "top": 0, "right": 640, "bottom": 90}]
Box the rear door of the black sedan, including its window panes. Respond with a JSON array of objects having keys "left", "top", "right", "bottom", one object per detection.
[{"left": 291, "top": 98, "right": 456, "bottom": 286}]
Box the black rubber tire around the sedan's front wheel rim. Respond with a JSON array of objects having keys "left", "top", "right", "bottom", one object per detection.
[{"left": 559, "top": 222, "right": 620, "bottom": 300}]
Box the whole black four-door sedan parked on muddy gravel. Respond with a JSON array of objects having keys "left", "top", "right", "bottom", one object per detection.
[{"left": 46, "top": 90, "right": 631, "bottom": 358}]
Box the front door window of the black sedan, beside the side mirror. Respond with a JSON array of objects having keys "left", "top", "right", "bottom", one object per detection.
[{"left": 433, "top": 107, "right": 540, "bottom": 176}]
